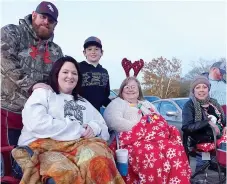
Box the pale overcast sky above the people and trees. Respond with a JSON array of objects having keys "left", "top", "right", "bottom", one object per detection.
[{"left": 0, "top": 0, "right": 226, "bottom": 89}]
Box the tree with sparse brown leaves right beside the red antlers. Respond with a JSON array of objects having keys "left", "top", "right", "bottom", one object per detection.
[{"left": 142, "top": 57, "right": 181, "bottom": 98}]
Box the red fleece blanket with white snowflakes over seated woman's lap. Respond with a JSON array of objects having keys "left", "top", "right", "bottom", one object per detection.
[{"left": 110, "top": 113, "right": 191, "bottom": 184}]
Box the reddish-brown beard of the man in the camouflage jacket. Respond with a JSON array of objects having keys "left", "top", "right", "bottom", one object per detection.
[{"left": 32, "top": 19, "right": 53, "bottom": 40}]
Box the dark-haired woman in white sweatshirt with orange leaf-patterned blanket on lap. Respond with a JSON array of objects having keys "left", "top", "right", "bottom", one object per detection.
[{"left": 13, "top": 56, "right": 124, "bottom": 184}]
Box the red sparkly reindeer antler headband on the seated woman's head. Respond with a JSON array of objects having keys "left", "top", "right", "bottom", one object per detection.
[{"left": 121, "top": 58, "right": 144, "bottom": 77}]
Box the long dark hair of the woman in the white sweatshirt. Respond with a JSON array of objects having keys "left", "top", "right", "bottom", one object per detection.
[{"left": 48, "top": 56, "right": 82, "bottom": 100}]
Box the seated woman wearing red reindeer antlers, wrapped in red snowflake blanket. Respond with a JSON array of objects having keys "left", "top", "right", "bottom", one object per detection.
[{"left": 104, "top": 59, "right": 191, "bottom": 184}]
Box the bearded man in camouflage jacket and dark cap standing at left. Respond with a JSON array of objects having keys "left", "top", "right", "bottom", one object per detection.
[{"left": 1, "top": 1, "right": 63, "bottom": 144}]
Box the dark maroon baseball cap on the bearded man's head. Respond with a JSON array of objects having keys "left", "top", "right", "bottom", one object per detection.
[{"left": 35, "top": 1, "right": 58, "bottom": 21}]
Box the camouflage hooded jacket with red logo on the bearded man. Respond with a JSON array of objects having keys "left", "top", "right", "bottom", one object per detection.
[{"left": 1, "top": 15, "right": 63, "bottom": 113}]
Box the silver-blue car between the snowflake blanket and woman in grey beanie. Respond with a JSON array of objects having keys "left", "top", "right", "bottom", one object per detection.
[{"left": 152, "top": 98, "right": 189, "bottom": 134}]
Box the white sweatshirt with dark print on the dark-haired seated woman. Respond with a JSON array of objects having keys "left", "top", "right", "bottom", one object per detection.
[{"left": 18, "top": 88, "right": 109, "bottom": 145}]
